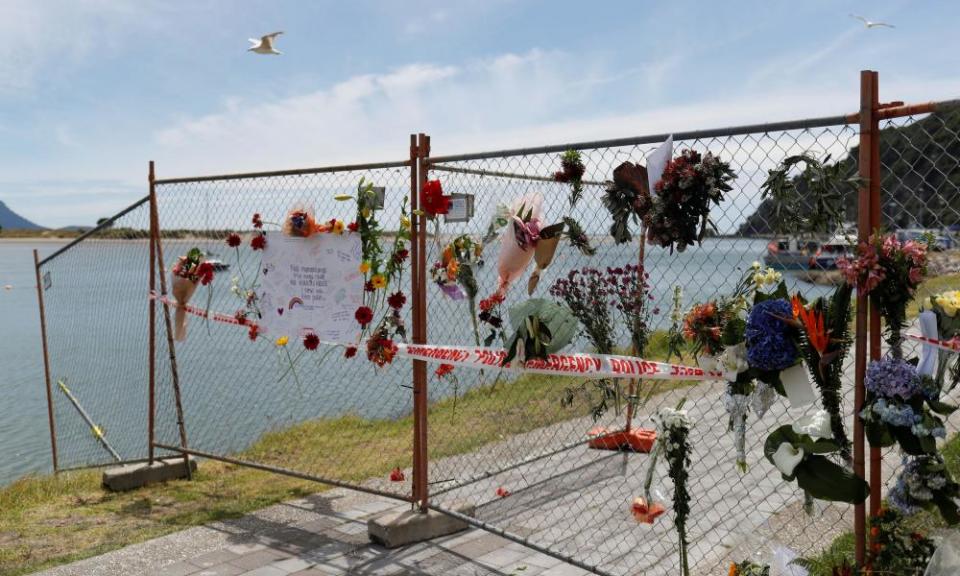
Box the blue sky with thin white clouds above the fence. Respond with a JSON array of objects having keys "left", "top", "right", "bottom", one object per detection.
[{"left": 0, "top": 0, "right": 960, "bottom": 227}]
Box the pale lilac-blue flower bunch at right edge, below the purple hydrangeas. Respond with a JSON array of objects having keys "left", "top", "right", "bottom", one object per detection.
[{"left": 887, "top": 454, "right": 960, "bottom": 525}]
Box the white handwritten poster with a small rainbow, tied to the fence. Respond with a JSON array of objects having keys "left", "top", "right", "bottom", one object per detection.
[{"left": 260, "top": 234, "right": 363, "bottom": 342}]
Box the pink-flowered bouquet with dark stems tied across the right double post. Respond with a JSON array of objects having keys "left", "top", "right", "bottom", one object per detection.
[{"left": 837, "top": 234, "right": 927, "bottom": 358}]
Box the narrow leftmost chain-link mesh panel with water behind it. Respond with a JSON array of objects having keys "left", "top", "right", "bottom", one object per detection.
[{"left": 40, "top": 198, "right": 150, "bottom": 469}]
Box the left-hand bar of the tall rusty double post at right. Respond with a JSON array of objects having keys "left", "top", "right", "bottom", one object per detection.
[{"left": 853, "top": 70, "right": 876, "bottom": 566}]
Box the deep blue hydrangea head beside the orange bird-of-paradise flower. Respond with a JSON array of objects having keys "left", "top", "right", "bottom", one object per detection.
[{"left": 746, "top": 298, "right": 797, "bottom": 370}]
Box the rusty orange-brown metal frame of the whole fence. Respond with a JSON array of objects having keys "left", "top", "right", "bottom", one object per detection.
[{"left": 34, "top": 70, "right": 960, "bottom": 572}]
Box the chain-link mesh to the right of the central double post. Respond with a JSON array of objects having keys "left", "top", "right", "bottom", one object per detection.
[{"left": 420, "top": 108, "right": 960, "bottom": 574}]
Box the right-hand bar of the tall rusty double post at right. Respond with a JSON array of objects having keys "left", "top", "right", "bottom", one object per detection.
[{"left": 857, "top": 72, "right": 880, "bottom": 516}]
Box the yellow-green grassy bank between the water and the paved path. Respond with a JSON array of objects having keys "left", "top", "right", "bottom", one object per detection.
[{"left": 0, "top": 335, "right": 685, "bottom": 576}]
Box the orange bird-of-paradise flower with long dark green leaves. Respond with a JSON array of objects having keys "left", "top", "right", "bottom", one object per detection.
[{"left": 791, "top": 286, "right": 852, "bottom": 462}]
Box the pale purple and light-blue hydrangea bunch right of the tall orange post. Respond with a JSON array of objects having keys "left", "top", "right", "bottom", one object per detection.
[{"left": 860, "top": 357, "right": 956, "bottom": 455}]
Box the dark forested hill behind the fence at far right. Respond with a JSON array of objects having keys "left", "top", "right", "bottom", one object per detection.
[{"left": 738, "top": 109, "right": 960, "bottom": 236}]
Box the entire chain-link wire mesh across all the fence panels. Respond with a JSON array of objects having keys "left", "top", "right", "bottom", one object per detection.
[{"left": 31, "top": 94, "right": 960, "bottom": 574}]
